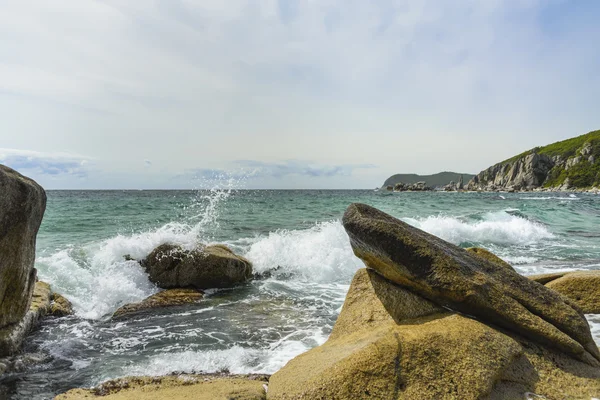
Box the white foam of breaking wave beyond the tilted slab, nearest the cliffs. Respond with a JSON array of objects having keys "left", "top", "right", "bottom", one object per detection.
[{"left": 404, "top": 211, "right": 554, "bottom": 245}]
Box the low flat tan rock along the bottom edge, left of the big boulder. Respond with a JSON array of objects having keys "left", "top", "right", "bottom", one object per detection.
[{"left": 54, "top": 374, "right": 268, "bottom": 400}]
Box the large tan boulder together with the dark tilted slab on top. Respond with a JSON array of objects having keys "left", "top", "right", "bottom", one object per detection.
[{"left": 267, "top": 204, "right": 600, "bottom": 400}]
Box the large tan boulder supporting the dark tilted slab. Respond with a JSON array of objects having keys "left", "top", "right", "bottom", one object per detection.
[{"left": 268, "top": 269, "right": 600, "bottom": 400}]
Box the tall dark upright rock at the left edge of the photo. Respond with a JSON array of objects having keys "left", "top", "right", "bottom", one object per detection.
[{"left": 0, "top": 165, "right": 46, "bottom": 328}]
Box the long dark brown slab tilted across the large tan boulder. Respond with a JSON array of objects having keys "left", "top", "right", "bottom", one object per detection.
[{"left": 343, "top": 204, "right": 600, "bottom": 366}]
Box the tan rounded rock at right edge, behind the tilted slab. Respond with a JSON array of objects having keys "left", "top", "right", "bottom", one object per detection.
[{"left": 546, "top": 271, "right": 600, "bottom": 314}]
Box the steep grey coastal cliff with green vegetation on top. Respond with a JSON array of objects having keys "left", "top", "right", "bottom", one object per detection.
[{"left": 466, "top": 130, "right": 600, "bottom": 190}]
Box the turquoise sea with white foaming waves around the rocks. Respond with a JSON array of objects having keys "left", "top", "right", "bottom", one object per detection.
[{"left": 0, "top": 189, "right": 600, "bottom": 400}]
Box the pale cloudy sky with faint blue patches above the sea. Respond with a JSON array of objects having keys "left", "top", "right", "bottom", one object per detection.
[{"left": 0, "top": 0, "right": 600, "bottom": 189}]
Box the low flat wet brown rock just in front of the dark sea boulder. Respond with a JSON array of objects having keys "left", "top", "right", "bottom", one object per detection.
[{"left": 112, "top": 289, "right": 203, "bottom": 319}]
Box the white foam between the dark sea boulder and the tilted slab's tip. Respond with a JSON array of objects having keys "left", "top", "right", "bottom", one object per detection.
[{"left": 241, "top": 221, "right": 363, "bottom": 282}]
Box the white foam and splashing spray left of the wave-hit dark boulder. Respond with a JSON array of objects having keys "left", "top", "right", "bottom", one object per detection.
[{"left": 36, "top": 189, "right": 231, "bottom": 319}]
